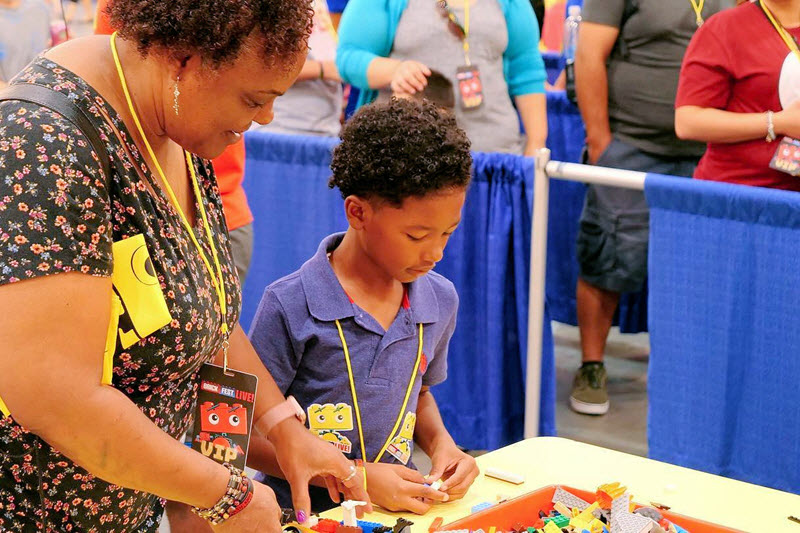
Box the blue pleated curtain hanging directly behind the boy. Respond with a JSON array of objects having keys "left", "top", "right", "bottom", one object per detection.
[{"left": 242, "top": 133, "right": 555, "bottom": 449}]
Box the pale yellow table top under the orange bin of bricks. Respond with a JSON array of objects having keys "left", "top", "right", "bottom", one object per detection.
[{"left": 322, "top": 437, "right": 800, "bottom": 533}]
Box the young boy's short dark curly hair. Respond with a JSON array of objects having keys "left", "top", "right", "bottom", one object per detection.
[{"left": 328, "top": 98, "right": 472, "bottom": 206}]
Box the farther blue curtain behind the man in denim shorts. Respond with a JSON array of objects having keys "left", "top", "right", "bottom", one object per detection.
[{"left": 547, "top": 92, "right": 647, "bottom": 333}]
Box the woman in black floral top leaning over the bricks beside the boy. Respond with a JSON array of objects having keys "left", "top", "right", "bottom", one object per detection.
[{"left": 0, "top": 0, "right": 366, "bottom": 532}]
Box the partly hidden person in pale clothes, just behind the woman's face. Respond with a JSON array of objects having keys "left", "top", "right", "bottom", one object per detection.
[{"left": 255, "top": 0, "right": 344, "bottom": 137}]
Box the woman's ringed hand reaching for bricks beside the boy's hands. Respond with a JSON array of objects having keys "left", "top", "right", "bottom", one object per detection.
[{"left": 269, "top": 419, "right": 372, "bottom": 523}]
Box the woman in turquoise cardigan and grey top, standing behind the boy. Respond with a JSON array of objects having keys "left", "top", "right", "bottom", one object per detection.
[{"left": 336, "top": 0, "right": 547, "bottom": 155}]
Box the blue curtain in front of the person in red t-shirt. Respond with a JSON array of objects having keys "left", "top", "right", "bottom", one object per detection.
[{"left": 645, "top": 176, "right": 800, "bottom": 493}]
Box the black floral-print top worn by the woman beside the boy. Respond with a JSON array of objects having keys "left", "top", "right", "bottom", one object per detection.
[{"left": 0, "top": 57, "right": 240, "bottom": 533}]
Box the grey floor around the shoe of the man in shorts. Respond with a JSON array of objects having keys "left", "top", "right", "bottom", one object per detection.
[{"left": 553, "top": 323, "right": 650, "bottom": 456}]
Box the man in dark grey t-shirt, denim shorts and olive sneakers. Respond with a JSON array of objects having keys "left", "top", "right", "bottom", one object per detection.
[{"left": 570, "top": 0, "right": 732, "bottom": 415}]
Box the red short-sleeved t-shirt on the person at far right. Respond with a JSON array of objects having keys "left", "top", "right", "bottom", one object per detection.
[{"left": 675, "top": 2, "right": 800, "bottom": 191}]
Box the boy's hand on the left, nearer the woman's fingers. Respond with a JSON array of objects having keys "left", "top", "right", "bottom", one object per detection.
[{"left": 366, "top": 463, "right": 449, "bottom": 514}]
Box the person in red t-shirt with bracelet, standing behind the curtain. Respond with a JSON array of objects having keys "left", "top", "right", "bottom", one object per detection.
[{"left": 675, "top": 0, "right": 800, "bottom": 191}]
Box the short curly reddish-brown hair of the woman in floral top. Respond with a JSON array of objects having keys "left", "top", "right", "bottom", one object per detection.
[{"left": 107, "top": 0, "right": 314, "bottom": 67}]
